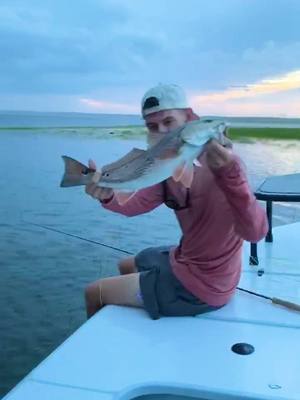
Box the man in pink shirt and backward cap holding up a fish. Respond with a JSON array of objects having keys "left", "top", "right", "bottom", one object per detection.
[{"left": 86, "top": 85, "right": 268, "bottom": 319}]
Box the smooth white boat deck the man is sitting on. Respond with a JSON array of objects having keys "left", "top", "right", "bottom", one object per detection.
[{"left": 5, "top": 223, "right": 300, "bottom": 400}]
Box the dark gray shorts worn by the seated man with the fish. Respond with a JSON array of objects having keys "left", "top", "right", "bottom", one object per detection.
[{"left": 135, "top": 246, "right": 219, "bottom": 319}]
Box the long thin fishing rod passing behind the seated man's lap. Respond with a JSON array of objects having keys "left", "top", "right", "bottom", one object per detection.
[{"left": 23, "top": 220, "right": 300, "bottom": 311}]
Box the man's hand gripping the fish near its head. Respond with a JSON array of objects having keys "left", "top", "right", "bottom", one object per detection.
[{"left": 206, "top": 140, "right": 234, "bottom": 171}]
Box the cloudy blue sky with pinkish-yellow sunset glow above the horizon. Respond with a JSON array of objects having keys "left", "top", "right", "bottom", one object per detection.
[{"left": 0, "top": 0, "right": 300, "bottom": 117}]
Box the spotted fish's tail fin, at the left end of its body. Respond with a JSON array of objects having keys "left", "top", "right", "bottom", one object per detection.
[{"left": 60, "top": 156, "right": 95, "bottom": 187}]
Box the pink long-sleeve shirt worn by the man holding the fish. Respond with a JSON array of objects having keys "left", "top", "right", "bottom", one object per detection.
[{"left": 102, "top": 156, "right": 268, "bottom": 306}]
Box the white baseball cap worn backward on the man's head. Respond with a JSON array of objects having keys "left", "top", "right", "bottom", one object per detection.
[{"left": 141, "top": 84, "right": 189, "bottom": 117}]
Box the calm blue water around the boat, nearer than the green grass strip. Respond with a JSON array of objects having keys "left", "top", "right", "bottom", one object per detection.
[{"left": 0, "top": 130, "right": 300, "bottom": 397}]
